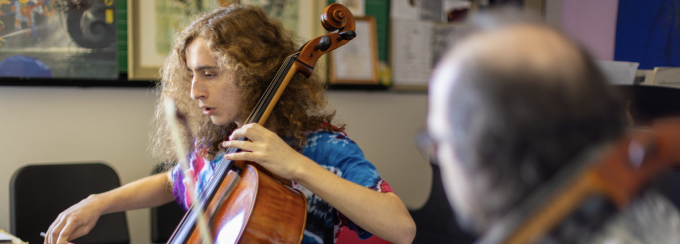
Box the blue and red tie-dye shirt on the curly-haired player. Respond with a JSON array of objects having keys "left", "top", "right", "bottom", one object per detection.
[{"left": 172, "top": 130, "right": 393, "bottom": 244}]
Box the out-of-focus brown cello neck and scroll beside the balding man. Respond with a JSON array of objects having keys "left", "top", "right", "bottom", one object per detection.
[{"left": 476, "top": 118, "right": 680, "bottom": 244}]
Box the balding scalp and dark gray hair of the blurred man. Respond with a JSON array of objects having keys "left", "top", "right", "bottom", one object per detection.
[{"left": 437, "top": 7, "right": 625, "bottom": 232}]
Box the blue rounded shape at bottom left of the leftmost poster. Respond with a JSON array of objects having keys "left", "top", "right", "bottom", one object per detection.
[{"left": 0, "top": 55, "right": 52, "bottom": 78}]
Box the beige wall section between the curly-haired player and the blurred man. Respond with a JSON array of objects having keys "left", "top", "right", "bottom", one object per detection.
[{"left": 328, "top": 91, "right": 432, "bottom": 209}]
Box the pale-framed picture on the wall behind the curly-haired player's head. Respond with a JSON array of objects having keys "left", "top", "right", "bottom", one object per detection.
[{"left": 127, "top": 0, "right": 308, "bottom": 80}]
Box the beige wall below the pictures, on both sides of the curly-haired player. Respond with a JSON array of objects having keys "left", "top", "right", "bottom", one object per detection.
[{"left": 0, "top": 87, "right": 431, "bottom": 244}]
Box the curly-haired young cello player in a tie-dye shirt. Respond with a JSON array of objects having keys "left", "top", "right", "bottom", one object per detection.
[{"left": 45, "top": 5, "right": 415, "bottom": 244}]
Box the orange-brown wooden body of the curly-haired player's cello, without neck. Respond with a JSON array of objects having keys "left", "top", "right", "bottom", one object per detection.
[{"left": 186, "top": 164, "right": 307, "bottom": 243}]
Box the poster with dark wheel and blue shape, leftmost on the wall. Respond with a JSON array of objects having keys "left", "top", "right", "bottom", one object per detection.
[{"left": 0, "top": 0, "right": 119, "bottom": 80}]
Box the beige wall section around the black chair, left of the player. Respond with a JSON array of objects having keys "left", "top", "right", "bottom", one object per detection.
[{"left": 0, "top": 87, "right": 155, "bottom": 243}]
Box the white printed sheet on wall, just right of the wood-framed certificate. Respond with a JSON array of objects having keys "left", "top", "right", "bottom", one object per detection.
[{"left": 390, "top": 19, "right": 433, "bottom": 85}]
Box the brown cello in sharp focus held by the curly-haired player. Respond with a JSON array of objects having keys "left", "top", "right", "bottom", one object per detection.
[{"left": 166, "top": 4, "right": 356, "bottom": 244}]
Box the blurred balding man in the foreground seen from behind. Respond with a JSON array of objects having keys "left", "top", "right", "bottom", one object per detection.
[{"left": 427, "top": 10, "right": 680, "bottom": 243}]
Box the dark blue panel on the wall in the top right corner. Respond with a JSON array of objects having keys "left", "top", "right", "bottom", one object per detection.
[{"left": 614, "top": 0, "right": 680, "bottom": 69}]
